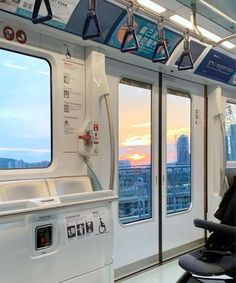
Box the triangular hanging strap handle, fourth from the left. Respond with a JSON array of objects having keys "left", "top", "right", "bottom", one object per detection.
[{"left": 152, "top": 20, "right": 170, "bottom": 63}]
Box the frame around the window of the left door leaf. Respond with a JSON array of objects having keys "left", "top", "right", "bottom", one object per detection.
[{"left": 116, "top": 76, "right": 154, "bottom": 228}]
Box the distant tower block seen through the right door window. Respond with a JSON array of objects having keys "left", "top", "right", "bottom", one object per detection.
[{"left": 177, "top": 135, "right": 190, "bottom": 164}]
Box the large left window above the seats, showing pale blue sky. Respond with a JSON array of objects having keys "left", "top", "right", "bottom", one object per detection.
[{"left": 0, "top": 49, "right": 51, "bottom": 169}]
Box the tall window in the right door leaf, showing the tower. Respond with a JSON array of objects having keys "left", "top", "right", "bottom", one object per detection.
[{"left": 166, "top": 89, "right": 191, "bottom": 214}]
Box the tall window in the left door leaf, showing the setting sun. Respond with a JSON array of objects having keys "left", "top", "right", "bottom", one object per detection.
[{"left": 118, "top": 79, "right": 152, "bottom": 224}]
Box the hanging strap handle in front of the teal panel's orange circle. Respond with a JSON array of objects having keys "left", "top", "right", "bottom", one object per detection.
[{"left": 120, "top": 5, "right": 139, "bottom": 53}]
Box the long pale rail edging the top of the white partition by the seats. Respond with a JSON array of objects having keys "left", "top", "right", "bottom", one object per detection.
[{"left": 0, "top": 196, "right": 117, "bottom": 219}]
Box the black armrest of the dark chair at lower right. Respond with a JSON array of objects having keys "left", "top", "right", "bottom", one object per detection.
[{"left": 194, "top": 219, "right": 236, "bottom": 237}]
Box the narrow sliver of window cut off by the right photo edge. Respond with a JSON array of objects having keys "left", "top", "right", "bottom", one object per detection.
[{"left": 225, "top": 102, "right": 236, "bottom": 161}]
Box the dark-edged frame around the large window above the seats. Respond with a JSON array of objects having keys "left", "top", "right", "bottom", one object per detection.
[{"left": 0, "top": 47, "right": 54, "bottom": 172}]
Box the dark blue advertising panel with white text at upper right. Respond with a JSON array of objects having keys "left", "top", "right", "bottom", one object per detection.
[{"left": 194, "top": 49, "right": 236, "bottom": 87}]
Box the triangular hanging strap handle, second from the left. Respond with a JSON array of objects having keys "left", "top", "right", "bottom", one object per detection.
[{"left": 82, "top": 0, "right": 102, "bottom": 40}]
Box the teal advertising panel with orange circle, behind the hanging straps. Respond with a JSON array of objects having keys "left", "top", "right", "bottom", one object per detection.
[{"left": 107, "top": 14, "right": 183, "bottom": 62}]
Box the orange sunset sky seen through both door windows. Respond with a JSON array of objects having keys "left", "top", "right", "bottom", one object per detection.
[{"left": 119, "top": 84, "right": 190, "bottom": 165}]
